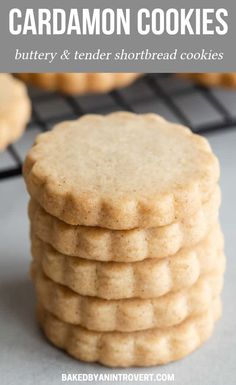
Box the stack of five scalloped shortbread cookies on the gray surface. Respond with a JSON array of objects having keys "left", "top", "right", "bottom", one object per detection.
[{"left": 24, "top": 112, "right": 225, "bottom": 366}]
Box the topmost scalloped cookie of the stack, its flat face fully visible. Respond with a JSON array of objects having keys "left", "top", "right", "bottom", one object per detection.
[{"left": 23, "top": 112, "right": 219, "bottom": 230}]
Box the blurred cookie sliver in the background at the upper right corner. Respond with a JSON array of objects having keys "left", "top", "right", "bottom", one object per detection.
[{"left": 179, "top": 72, "right": 236, "bottom": 88}]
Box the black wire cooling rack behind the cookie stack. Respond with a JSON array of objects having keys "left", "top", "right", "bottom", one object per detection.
[{"left": 0, "top": 74, "right": 236, "bottom": 180}]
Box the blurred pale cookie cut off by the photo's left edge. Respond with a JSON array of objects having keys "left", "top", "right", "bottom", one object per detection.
[{"left": 0, "top": 74, "right": 31, "bottom": 151}]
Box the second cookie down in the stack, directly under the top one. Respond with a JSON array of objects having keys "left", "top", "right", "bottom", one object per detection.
[{"left": 29, "top": 186, "right": 221, "bottom": 262}]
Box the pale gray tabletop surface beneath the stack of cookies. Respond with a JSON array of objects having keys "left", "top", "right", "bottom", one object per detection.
[{"left": 0, "top": 129, "right": 236, "bottom": 385}]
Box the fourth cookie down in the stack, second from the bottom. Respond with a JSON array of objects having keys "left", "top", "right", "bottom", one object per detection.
[{"left": 32, "top": 258, "right": 225, "bottom": 332}]
